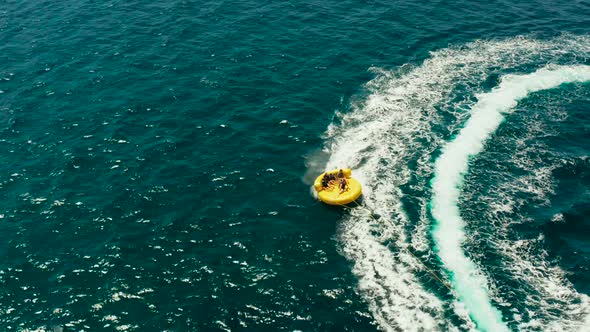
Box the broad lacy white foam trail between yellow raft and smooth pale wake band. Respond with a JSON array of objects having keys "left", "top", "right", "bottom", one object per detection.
[{"left": 325, "top": 36, "right": 590, "bottom": 331}]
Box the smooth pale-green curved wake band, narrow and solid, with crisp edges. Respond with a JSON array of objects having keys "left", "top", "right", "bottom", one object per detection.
[{"left": 432, "top": 65, "right": 590, "bottom": 331}]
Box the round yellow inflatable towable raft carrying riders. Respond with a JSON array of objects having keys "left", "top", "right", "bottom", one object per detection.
[{"left": 313, "top": 168, "right": 363, "bottom": 205}]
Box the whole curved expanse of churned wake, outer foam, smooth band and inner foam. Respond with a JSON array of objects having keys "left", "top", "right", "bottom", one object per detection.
[{"left": 322, "top": 35, "right": 590, "bottom": 331}]
